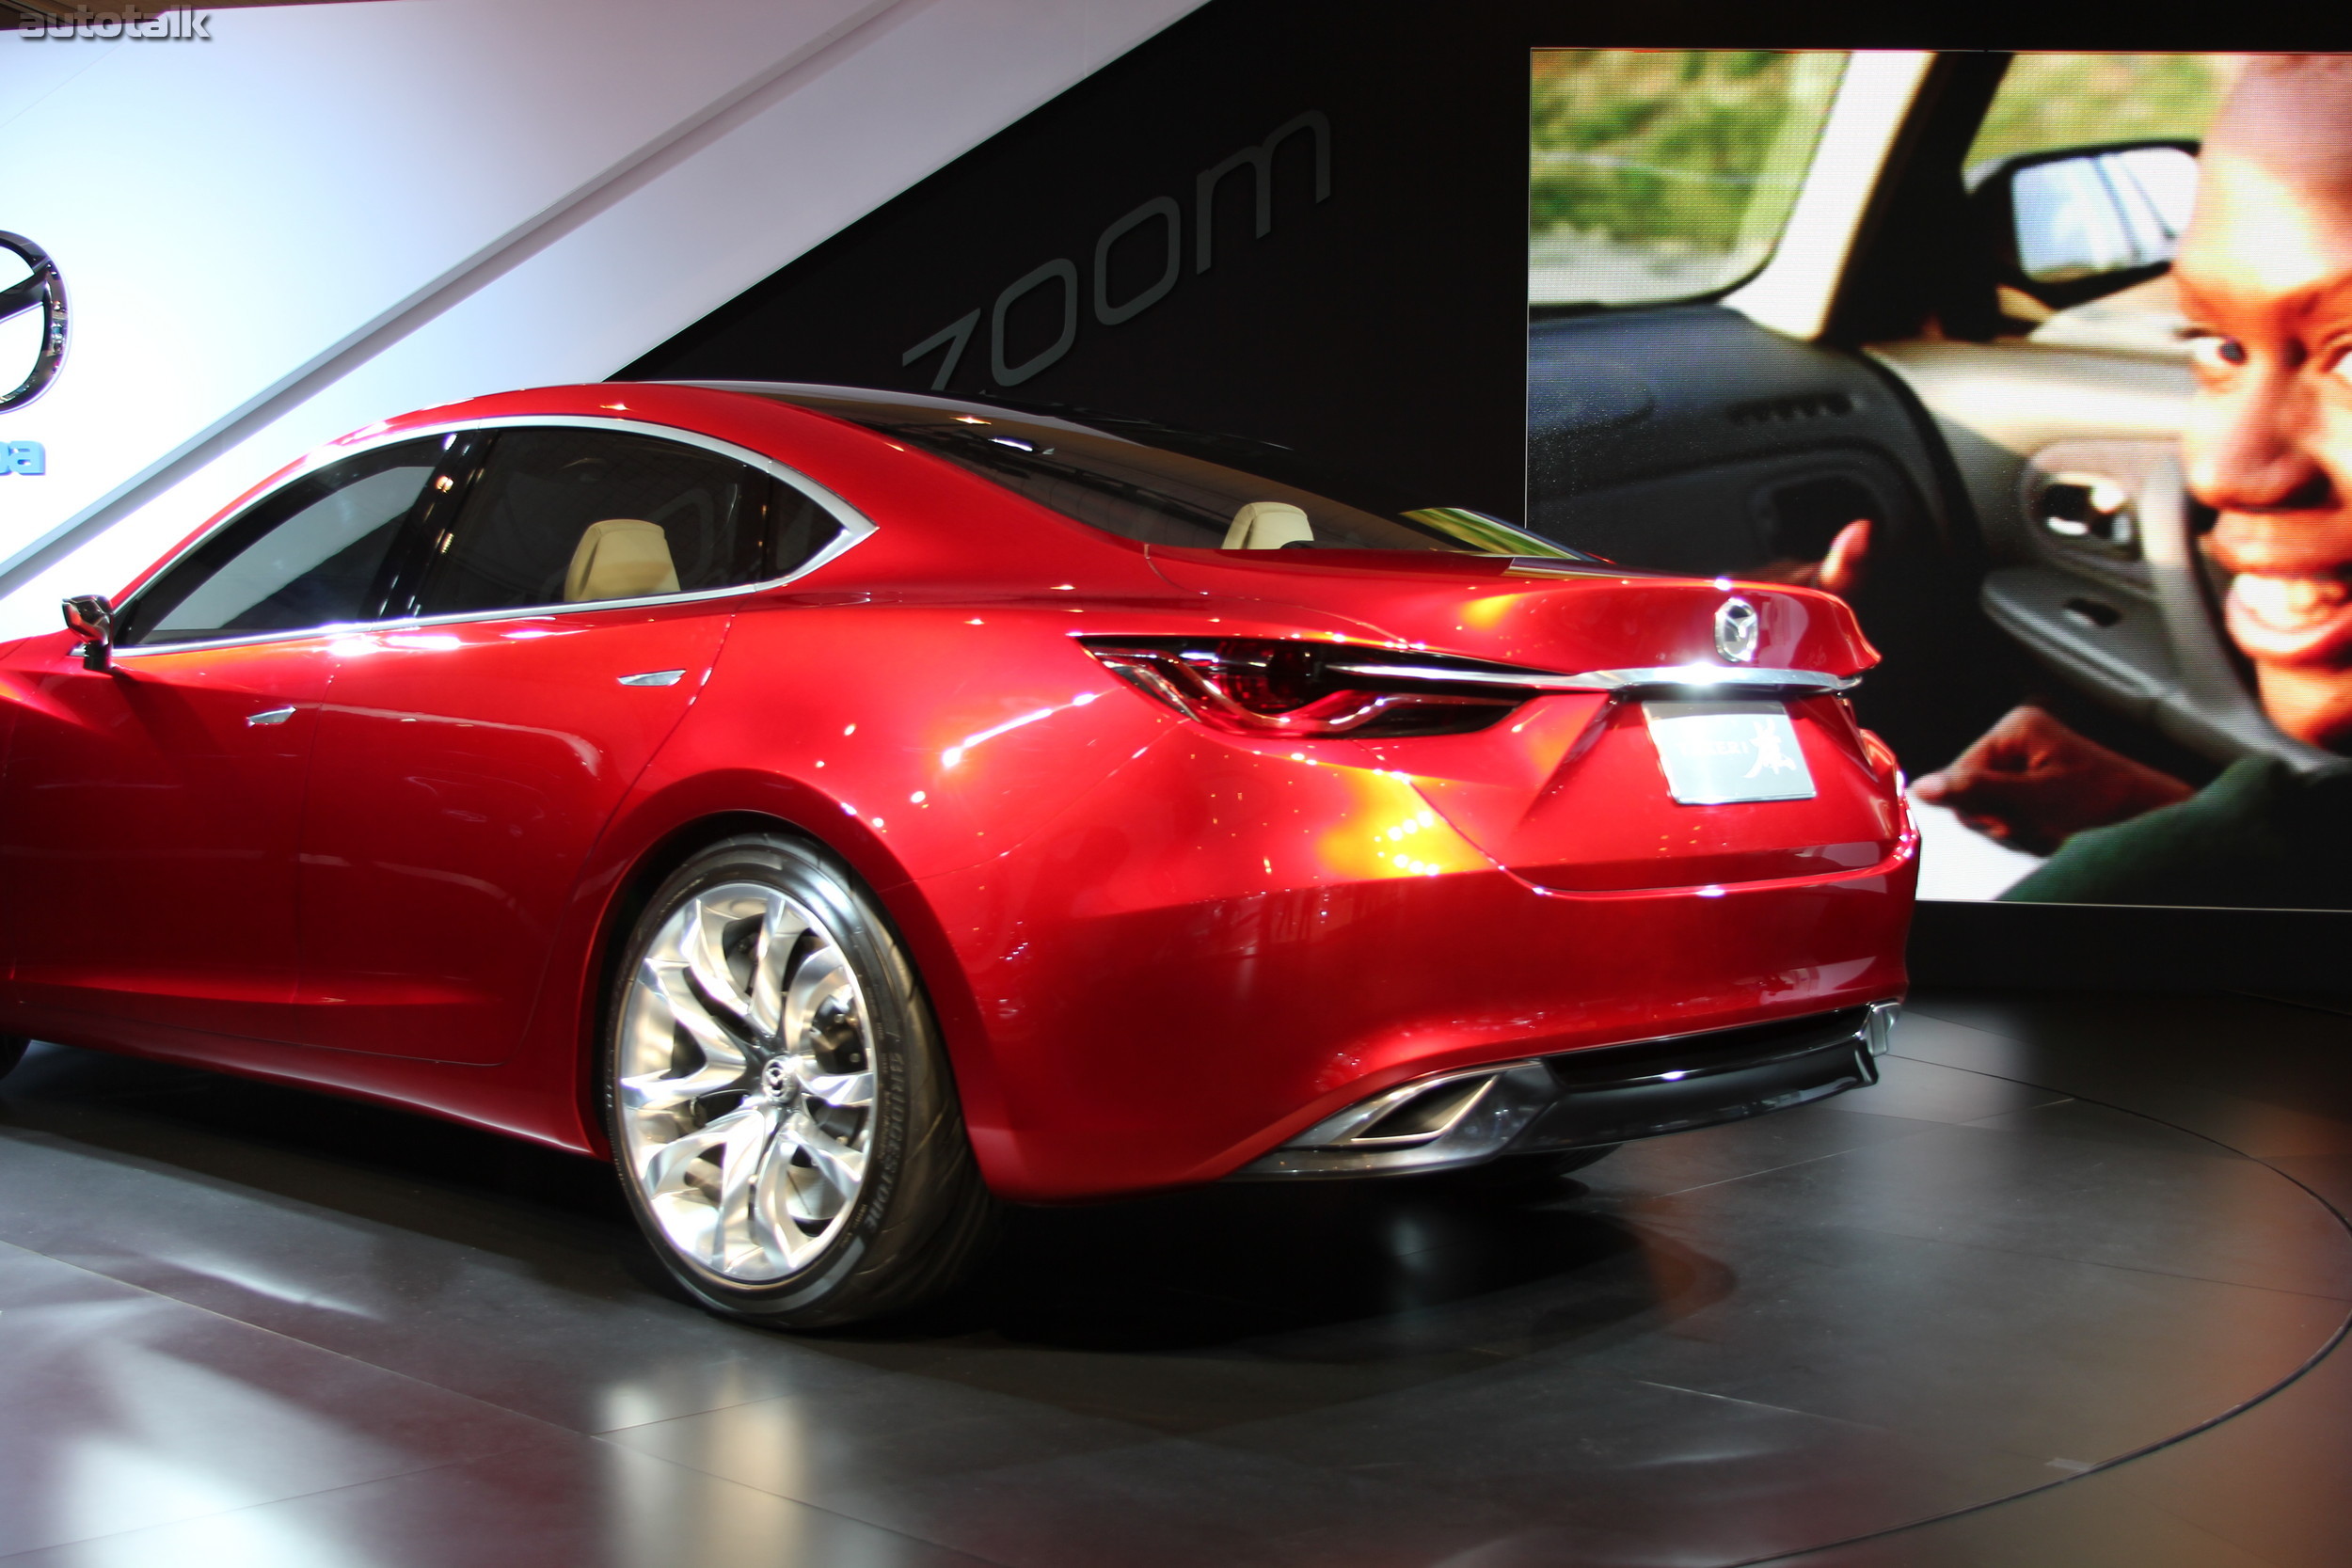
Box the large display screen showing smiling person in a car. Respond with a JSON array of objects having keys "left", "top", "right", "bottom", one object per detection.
[{"left": 1527, "top": 49, "right": 2352, "bottom": 908}]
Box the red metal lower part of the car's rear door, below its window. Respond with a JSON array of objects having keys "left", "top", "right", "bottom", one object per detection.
[{"left": 299, "top": 602, "right": 729, "bottom": 1063}]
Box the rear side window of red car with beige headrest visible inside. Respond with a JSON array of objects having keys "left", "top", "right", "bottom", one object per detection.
[{"left": 417, "top": 428, "right": 837, "bottom": 616}]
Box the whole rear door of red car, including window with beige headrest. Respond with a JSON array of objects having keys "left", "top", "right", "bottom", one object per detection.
[{"left": 278, "top": 420, "right": 800, "bottom": 1065}]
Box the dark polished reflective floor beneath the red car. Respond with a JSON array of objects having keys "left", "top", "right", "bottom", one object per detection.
[{"left": 0, "top": 994, "right": 2352, "bottom": 1568}]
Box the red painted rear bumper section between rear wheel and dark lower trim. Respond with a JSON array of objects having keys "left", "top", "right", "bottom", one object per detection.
[{"left": 908, "top": 734, "right": 1917, "bottom": 1201}]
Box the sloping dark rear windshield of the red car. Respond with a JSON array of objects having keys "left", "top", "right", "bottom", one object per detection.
[{"left": 696, "top": 383, "right": 1590, "bottom": 560}]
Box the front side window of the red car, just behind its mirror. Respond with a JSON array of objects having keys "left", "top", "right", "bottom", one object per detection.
[{"left": 118, "top": 435, "right": 450, "bottom": 646}]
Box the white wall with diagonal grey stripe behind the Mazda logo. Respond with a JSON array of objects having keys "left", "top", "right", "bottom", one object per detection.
[{"left": 0, "top": 0, "right": 1198, "bottom": 637}]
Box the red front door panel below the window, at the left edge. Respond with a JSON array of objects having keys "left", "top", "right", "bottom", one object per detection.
[{"left": 0, "top": 635, "right": 329, "bottom": 1039}]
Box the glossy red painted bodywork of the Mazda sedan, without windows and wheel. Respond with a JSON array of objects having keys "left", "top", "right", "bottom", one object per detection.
[{"left": 0, "top": 386, "right": 1915, "bottom": 1201}]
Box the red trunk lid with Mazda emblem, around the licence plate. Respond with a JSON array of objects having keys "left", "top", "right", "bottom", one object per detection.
[{"left": 1152, "top": 547, "right": 1910, "bottom": 895}]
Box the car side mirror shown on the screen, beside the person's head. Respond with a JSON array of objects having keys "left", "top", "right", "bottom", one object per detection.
[{"left": 1969, "top": 141, "right": 2197, "bottom": 310}]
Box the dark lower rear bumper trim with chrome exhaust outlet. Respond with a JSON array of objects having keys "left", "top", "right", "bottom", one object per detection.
[{"left": 1228, "top": 1002, "right": 1896, "bottom": 1180}]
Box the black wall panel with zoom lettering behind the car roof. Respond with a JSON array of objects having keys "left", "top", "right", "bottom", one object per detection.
[{"left": 624, "top": 0, "right": 1527, "bottom": 515}]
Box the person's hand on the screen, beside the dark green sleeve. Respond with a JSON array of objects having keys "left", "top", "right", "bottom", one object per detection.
[{"left": 1913, "top": 707, "right": 2195, "bottom": 856}]
